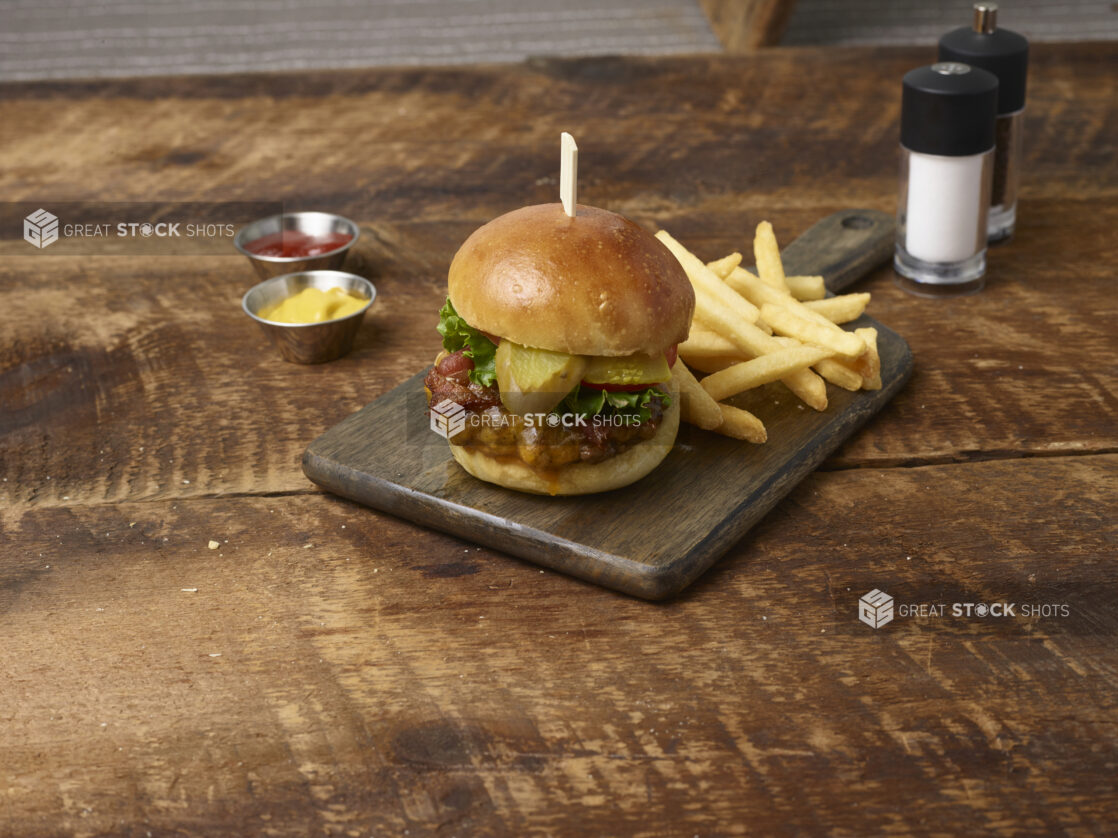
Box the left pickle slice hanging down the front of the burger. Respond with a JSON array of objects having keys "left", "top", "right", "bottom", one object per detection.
[{"left": 496, "top": 341, "right": 587, "bottom": 416}]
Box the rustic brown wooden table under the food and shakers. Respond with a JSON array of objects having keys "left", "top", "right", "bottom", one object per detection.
[{"left": 0, "top": 44, "right": 1118, "bottom": 836}]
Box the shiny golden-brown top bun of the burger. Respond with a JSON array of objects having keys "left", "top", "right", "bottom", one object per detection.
[{"left": 447, "top": 203, "right": 694, "bottom": 356}]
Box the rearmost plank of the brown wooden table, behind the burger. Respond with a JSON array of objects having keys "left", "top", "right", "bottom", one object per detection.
[{"left": 0, "top": 44, "right": 1118, "bottom": 216}]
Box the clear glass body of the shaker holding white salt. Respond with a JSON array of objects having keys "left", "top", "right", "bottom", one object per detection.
[{"left": 893, "top": 145, "right": 994, "bottom": 296}]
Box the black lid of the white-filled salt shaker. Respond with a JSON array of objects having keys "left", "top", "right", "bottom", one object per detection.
[{"left": 901, "top": 61, "right": 997, "bottom": 158}]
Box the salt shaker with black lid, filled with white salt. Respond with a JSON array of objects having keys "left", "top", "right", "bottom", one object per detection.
[{"left": 893, "top": 61, "right": 997, "bottom": 296}]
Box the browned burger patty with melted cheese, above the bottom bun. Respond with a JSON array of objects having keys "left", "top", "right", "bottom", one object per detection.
[{"left": 424, "top": 351, "right": 664, "bottom": 468}]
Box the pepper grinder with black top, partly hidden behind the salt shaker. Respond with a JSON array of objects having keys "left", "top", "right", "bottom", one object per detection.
[{"left": 939, "top": 2, "right": 1029, "bottom": 244}]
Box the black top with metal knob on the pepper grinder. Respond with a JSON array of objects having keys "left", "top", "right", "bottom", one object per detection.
[{"left": 939, "top": 2, "right": 1029, "bottom": 114}]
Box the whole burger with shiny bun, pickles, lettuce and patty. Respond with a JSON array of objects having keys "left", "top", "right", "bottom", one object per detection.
[{"left": 425, "top": 203, "right": 694, "bottom": 495}]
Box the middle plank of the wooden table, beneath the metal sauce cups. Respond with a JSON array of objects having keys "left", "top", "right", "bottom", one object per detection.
[{"left": 0, "top": 201, "right": 1118, "bottom": 504}]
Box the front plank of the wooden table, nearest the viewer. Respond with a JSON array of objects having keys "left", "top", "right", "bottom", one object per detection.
[{"left": 0, "top": 455, "right": 1118, "bottom": 836}]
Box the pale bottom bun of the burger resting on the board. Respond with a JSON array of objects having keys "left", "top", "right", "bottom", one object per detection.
[{"left": 451, "top": 380, "right": 680, "bottom": 495}]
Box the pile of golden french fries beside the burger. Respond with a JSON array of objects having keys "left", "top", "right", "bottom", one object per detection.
[{"left": 656, "top": 221, "right": 881, "bottom": 442}]
